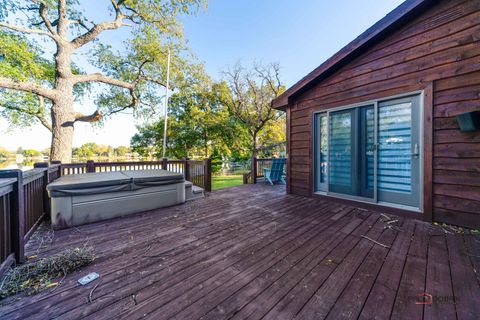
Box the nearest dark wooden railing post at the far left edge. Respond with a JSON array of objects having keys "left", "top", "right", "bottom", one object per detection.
[{"left": 0, "top": 169, "right": 25, "bottom": 263}]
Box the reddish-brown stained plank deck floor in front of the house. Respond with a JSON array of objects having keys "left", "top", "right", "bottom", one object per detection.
[{"left": 0, "top": 184, "right": 480, "bottom": 319}]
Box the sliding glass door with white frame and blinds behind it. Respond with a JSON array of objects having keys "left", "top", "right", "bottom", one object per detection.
[{"left": 314, "top": 96, "right": 420, "bottom": 207}]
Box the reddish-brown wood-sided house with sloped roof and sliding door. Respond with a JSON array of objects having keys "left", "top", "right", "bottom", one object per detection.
[{"left": 272, "top": 0, "right": 480, "bottom": 228}]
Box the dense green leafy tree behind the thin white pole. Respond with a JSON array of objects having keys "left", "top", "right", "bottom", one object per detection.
[{"left": 131, "top": 76, "right": 241, "bottom": 159}]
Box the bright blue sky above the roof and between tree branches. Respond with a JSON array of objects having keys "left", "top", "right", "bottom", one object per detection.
[{"left": 0, "top": 0, "right": 402, "bottom": 150}]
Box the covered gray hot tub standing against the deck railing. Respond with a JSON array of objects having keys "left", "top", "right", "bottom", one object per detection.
[{"left": 47, "top": 170, "right": 185, "bottom": 229}]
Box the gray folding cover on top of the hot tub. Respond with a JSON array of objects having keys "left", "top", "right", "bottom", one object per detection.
[{"left": 47, "top": 170, "right": 185, "bottom": 197}]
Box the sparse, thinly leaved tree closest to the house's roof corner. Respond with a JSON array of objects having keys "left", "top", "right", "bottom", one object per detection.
[{"left": 224, "top": 63, "right": 285, "bottom": 157}]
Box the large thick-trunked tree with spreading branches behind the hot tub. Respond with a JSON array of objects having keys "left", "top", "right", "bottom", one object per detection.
[{"left": 0, "top": 0, "right": 203, "bottom": 162}]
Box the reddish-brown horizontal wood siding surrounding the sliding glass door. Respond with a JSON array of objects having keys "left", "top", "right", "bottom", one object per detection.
[{"left": 289, "top": 0, "right": 480, "bottom": 227}]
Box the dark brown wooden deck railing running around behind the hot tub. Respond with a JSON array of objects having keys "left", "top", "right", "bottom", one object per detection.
[{"left": 0, "top": 159, "right": 212, "bottom": 275}]
